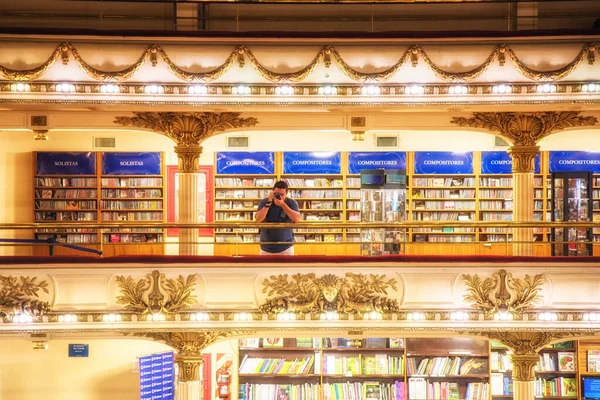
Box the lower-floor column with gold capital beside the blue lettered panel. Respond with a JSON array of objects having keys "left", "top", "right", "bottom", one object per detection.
[{"left": 137, "top": 331, "right": 251, "bottom": 400}]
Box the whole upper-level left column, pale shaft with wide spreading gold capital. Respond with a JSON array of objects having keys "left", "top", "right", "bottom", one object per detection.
[{"left": 115, "top": 112, "right": 258, "bottom": 255}]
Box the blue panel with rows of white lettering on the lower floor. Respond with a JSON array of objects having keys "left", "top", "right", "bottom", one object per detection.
[{"left": 139, "top": 352, "right": 175, "bottom": 400}]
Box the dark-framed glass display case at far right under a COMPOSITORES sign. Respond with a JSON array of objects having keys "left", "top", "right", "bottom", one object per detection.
[{"left": 552, "top": 172, "right": 592, "bottom": 256}]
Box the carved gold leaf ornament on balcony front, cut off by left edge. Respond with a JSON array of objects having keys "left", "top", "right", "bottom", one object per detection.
[{"left": 0, "top": 275, "right": 50, "bottom": 317}]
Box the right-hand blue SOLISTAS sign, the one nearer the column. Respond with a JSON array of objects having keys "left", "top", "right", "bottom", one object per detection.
[{"left": 102, "top": 152, "right": 160, "bottom": 175}]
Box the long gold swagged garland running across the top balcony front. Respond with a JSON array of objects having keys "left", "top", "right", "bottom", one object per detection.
[{"left": 0, "top": 43, "right": 598, "bottom": 83}]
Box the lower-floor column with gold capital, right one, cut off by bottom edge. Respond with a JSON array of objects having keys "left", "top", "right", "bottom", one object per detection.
[{"left": 483, "top": 332, "right": 575, "bottom": 400}]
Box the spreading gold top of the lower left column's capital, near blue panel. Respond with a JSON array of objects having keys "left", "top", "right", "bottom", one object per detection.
[{"left": 134, "top": 330, "right": 252, "bottom": 357}]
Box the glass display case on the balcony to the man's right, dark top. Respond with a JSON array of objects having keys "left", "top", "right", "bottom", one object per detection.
[{"left": 360, "top": 170, "right": 407, "bottom": 256}]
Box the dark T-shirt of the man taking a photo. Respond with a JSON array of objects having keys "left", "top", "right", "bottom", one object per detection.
[{"left": 258, "top": 197, "right": 300, "bottom": 253}]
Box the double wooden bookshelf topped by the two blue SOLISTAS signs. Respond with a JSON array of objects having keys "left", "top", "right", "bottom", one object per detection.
[{"left": 34, "top": 152, "right": 165, "bottom": 256}]
